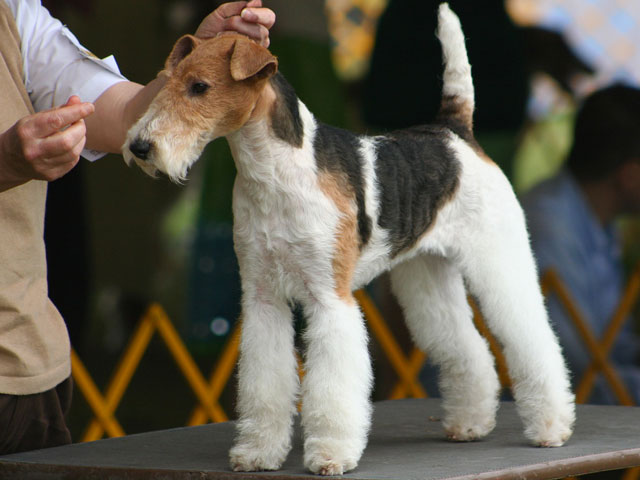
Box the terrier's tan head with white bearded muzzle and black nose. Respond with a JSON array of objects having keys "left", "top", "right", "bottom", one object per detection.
[{"left": 122, "top": 34, "right": 278, "bottom": 181}]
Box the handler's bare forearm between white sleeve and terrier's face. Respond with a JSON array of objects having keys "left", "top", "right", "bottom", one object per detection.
[{"left": 86, "top": 75, "right": 166, "bottom": 153}]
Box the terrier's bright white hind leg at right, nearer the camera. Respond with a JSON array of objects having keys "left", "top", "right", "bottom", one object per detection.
[{"left": 457, "top": 171, "right": 575, "bottom": 446}]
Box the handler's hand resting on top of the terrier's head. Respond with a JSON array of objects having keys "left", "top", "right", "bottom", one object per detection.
[{"left": 195, "top": 0, "right": 276, "bottom": 47}]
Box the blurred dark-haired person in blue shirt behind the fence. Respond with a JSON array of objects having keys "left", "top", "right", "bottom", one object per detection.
[{"left": 522, "top": 85, "right": 640, "bottom": 403}]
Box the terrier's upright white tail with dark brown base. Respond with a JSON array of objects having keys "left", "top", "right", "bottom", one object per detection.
[{"left": 437, "top": 3, "right": 475, "bottom": 132}]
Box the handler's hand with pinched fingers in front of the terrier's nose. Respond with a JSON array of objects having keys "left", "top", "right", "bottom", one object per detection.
[{"left": 0, "top": 95, "right": 94, "bottom": 191}]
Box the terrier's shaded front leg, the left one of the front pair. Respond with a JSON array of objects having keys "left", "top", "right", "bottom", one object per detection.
[{"left": 229, "top": 289, "right": 299, "bottom": 471}]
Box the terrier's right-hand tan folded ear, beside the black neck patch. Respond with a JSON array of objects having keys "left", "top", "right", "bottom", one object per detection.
[{"left": 230, "top": 39, "right": 278, "bottom": 81}]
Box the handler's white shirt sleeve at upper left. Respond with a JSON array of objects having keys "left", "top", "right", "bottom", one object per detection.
[{"left": 0, "top": 0, "right": 126, "bottom": 160}]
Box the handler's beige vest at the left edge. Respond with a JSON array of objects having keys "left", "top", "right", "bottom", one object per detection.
[{"left": 0, "top": 0, "right": 71, "bottom": 395}]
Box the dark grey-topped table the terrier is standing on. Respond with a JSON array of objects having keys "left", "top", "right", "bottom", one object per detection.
[{"left": 0, "top": 399, "right": 640, "bottom": 480}]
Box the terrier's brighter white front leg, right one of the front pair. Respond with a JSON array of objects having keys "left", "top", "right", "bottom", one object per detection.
[{"left": 302, "top": 297, "right": 372, "bottom": 475}]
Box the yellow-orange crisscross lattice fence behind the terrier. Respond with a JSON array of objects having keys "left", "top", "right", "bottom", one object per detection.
[{"left": 71, "top": 265, "right": 640, "bottom": 480}]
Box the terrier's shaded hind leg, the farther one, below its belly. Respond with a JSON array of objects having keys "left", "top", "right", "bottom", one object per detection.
[{"left": 391, "top": 255, "right": 500, "bottom": 441}]
